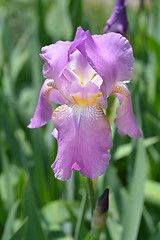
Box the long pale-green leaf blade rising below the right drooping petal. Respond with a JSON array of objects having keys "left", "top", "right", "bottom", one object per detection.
[{"left": 121, "top": 139, "right": 146, "bottom": 240}]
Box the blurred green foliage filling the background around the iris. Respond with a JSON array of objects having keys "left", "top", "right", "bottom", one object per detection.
[{"left": 0, "top": 0, "right": 160, "bottom": 240}]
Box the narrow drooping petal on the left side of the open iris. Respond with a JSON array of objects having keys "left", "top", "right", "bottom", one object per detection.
[{"left": 28, "top": 79, "right": 60, "bottom": 128}]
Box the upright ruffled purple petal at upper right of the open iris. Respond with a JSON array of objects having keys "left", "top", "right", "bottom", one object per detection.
[{"left": 77, "top": 31, "right": 134, "bottom": 100}]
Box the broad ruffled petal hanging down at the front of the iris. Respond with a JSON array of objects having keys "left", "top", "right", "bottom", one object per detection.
[{"left": 52, "top": 104, "right": 112, "bottom": 180}]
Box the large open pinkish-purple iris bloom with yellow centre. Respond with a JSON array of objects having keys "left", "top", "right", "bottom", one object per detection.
[{"left": 28, "top": 27, "right": 142, "bottom": 180}]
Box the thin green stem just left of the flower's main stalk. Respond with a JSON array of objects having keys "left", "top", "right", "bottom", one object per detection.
[{"left": 74, "top": 190, "right": 87, "bottom": 240}]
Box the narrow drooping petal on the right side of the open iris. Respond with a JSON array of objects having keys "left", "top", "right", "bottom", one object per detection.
[{"left": 112, "top": 82, "right": 143, "bottom": 138}]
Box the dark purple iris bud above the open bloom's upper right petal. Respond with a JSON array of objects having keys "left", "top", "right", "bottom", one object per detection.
[{"left": 104, "top": 0, "right": 128, "bottom": 35}]
